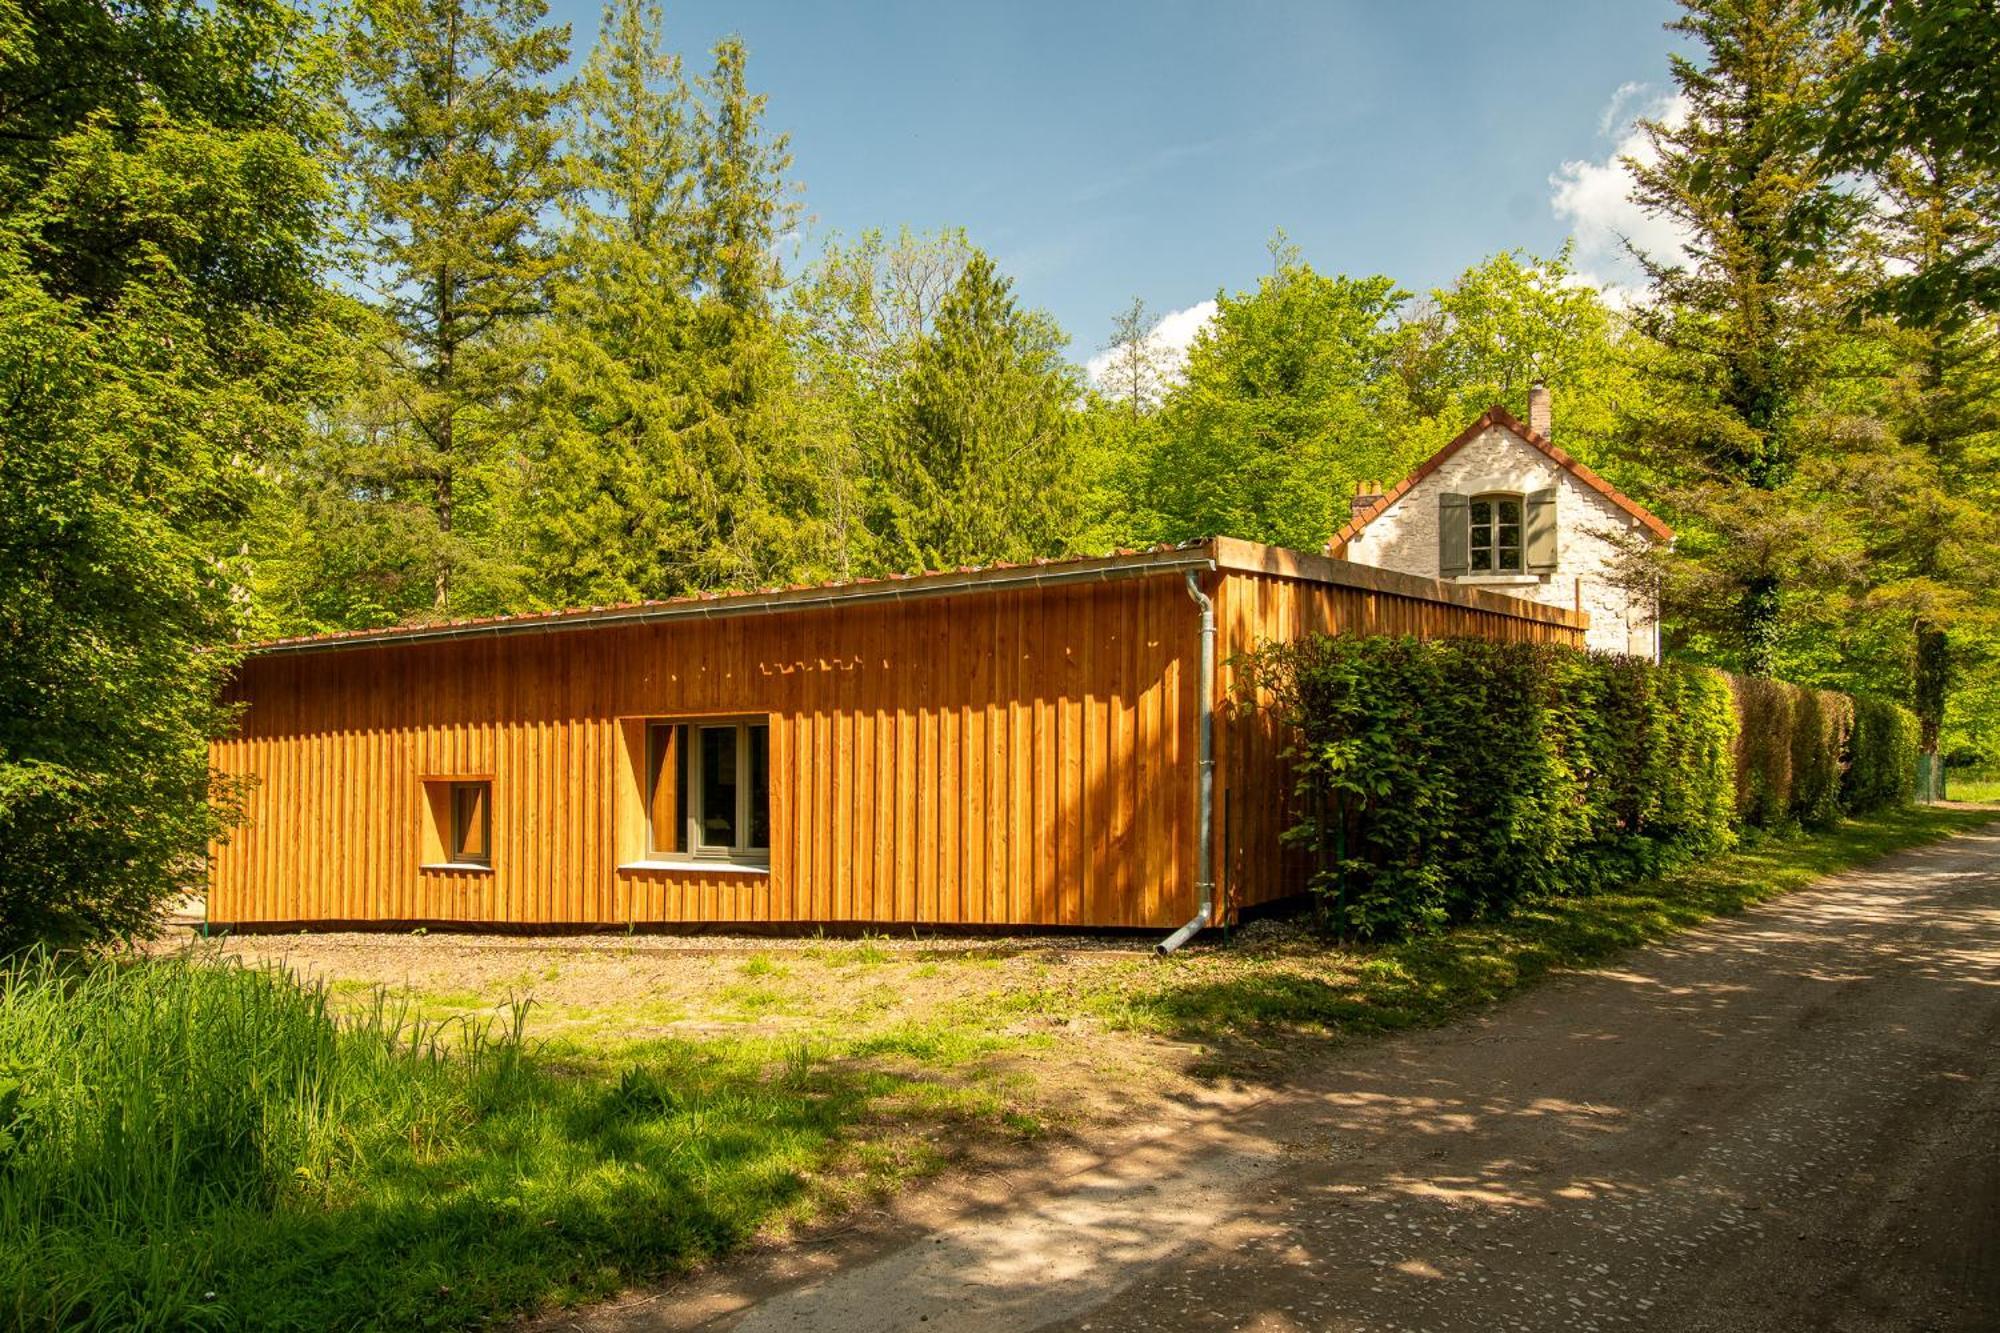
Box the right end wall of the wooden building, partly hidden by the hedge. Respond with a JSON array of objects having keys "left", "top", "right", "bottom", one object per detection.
[{"left": 1214, "top": 538, "right": 1588, "bottom": 919}]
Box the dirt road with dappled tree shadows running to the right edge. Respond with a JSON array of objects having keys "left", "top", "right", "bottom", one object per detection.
[{"left": 578, "top": 827, "right": 2000, "bottom": 1333}]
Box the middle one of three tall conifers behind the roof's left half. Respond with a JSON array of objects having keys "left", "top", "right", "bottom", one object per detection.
[{"left": 520, "top": 0, "right": 714, "bottom": 604}]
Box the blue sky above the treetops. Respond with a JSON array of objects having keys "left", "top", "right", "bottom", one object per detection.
[{"left": 554, "top": 0, "right": 1676, "bottom": 360}]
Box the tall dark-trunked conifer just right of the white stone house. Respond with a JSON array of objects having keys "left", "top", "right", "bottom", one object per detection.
[{"left": 1632, "top": 0, "right": 1854, "bottom": 675}]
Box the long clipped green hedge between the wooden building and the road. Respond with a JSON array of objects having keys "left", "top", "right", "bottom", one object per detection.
[{"left": 1240, "top": 636, "right": 1916, "bottom": 937}]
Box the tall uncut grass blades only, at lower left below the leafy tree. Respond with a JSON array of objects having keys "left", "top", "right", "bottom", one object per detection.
[{"left": 0, "top": 955, "right": 526, "bottom": 1327}]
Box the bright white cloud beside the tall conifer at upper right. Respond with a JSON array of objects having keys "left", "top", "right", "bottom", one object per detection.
[{"left": 1548, "top": 84, "right": 1688, "bottom": 304}]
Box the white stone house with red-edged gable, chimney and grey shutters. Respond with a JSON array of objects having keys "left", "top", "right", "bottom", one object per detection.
[{"left": 1326, "top": 384, "right": 1674, "bottom": 660}]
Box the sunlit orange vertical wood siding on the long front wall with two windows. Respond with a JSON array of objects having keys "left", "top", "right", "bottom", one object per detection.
[{"left": 210, "top": 574, "right": 1198, "bottom": 927}]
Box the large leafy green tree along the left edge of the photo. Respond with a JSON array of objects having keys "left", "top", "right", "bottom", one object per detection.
[{"left": 0, "top": 0, "right": 332, "bottom": 953}]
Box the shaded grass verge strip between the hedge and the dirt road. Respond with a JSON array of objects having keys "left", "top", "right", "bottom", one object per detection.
[{"left": 1086, "top": 807, "right": 1994, "bottom": 1048}]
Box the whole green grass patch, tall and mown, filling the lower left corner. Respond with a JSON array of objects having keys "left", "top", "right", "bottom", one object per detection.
[{"left": 0, "top": 957, "right": 894, "bottom": 1329}]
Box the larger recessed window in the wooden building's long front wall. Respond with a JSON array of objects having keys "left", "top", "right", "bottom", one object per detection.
[{"left": 646, "top": 719, "right": 770, "bottom": 863}]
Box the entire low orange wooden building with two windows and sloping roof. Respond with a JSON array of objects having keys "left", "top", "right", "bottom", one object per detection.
[{"left": 208, "top": 538, "right": 1588, "bottom": 929}]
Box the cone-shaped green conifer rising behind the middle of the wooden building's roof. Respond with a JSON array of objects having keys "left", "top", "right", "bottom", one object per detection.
[{"left": 876, "top": 252, "right": 1078, "bottom": 570}]
